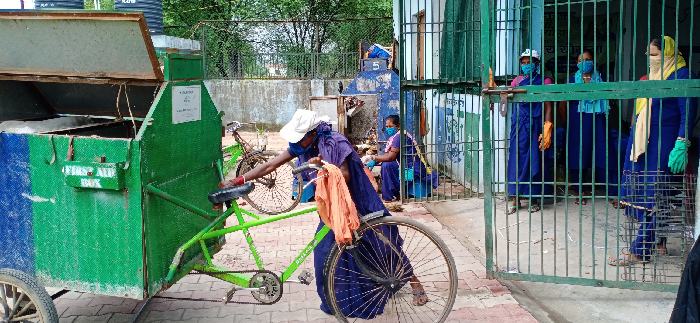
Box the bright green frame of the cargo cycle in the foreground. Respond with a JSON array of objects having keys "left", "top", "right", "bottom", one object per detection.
[{"left": 146, "top": 180, "right": 330, "bottom": 288}]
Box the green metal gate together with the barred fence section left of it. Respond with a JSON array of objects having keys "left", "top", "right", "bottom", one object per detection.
[{"left": 399, "top": 0, "right": 700, "bottom": 291}]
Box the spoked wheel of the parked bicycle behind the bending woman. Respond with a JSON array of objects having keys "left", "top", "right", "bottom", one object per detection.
[{"left": 236, "top": 152, "right": 303, "bottom": 215}]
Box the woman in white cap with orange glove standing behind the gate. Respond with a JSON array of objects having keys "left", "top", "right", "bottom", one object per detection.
[{"left": 507, "top": 49, "right": 554, "bottom": 214}]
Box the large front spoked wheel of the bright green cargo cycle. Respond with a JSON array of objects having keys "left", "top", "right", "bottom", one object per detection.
[{"left": 325, "top": 216, "right": 457, "bottom": 323}]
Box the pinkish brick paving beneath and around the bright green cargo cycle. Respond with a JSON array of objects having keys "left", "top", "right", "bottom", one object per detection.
[{"left": 56, "top": 204, "right": 537, "bottom": 322}]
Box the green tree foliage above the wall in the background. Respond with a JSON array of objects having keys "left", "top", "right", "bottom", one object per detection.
[{"left": 163, "top": 0, "right": 393, "bottom": 78}]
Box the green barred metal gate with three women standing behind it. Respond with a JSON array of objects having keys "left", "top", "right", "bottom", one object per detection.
[{"left": 481, "top": 0, "right": 700, "bottom": 291}]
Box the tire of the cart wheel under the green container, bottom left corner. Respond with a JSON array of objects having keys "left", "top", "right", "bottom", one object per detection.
[{"left": 0, "top": 268, "right": 58, "bottom": 323}]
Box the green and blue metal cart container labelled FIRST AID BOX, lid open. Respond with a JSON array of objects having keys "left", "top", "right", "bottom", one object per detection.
[{"left": 0, "top": 12, "right": 222, "bottom": 299}]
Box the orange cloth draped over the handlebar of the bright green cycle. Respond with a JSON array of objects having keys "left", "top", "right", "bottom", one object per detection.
[{"left": 315, "top": 164, "right": 360, "bottom": 245}]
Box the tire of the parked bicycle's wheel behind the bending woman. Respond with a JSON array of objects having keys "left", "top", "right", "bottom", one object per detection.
[{"left": 236, "top": 151, "right": 304, "bottom": 215}]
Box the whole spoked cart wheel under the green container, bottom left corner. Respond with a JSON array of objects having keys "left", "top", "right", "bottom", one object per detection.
[{"left": 0, "top": 269, "right": 58, "bottom": 323}]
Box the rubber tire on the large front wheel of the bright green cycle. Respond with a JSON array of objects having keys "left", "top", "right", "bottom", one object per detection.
[{"left": 324, "top": 216, "right": 458, "bottom": 322}]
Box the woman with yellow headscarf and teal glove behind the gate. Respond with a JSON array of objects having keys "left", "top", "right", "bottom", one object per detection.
[{"left": 610, "top": 36, "right": 697, "bottom": 266}]
